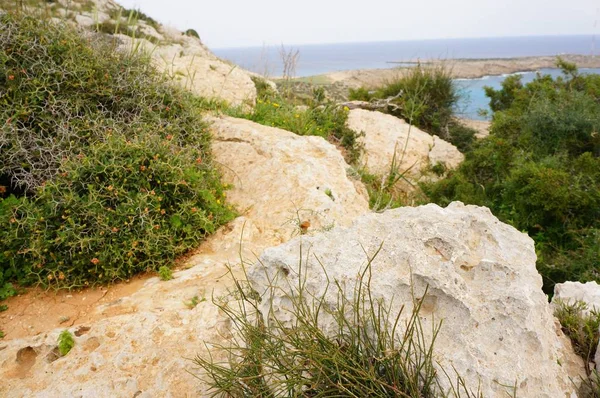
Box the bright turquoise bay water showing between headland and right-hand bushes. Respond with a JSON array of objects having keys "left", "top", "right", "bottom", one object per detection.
[{"left": 455, "top": 68, "right": 600, "bottom": 120}]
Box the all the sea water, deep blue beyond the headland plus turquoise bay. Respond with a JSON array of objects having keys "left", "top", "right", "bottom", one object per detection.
[{"left": 212, "top": 35, "right": 600, "bottom": 120}]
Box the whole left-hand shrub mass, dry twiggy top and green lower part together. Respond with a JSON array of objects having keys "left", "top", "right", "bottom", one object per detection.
[{"left": 0, "top": 14, "right": 232, "bottom": 298}]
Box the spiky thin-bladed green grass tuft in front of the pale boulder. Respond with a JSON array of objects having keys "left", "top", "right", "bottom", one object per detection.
[{"left": 194, "top": 244, "right": 481, "bottom": 398}]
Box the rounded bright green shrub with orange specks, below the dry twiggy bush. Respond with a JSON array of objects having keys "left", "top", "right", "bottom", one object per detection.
[{"left": 2, "top": 135, "right": 232, "bottom": 287}]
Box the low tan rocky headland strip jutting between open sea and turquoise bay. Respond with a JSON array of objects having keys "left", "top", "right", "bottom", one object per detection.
[{"left": 293, "top": 54, "right": 600, "bottom": 88}]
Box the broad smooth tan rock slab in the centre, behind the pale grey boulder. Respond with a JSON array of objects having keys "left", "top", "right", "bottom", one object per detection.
[{"left": 210, "top": 117, "right": 369, "bottom": 244}]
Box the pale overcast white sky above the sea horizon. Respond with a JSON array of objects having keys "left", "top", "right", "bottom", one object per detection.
[{"left": 117, "top": 0, "right": 600, "bottom": 48}]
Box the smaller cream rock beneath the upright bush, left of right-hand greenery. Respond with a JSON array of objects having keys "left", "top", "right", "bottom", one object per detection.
[{"left": 348, "top": 109, "right": 464, "bottom": 178}]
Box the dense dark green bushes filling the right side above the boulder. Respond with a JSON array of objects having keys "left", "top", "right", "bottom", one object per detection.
[{"left": 424, "top": 61, "right": 600, "bottom": 293}]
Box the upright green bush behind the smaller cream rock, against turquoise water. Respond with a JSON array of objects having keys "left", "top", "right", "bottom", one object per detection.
[{"left": 349, "top": 65, "right": 475, "bottom": 152}]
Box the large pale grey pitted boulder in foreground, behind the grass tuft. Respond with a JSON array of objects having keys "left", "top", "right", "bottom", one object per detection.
[{"left": 249, "top": 202, "right": 583, "bottom": 398}]
